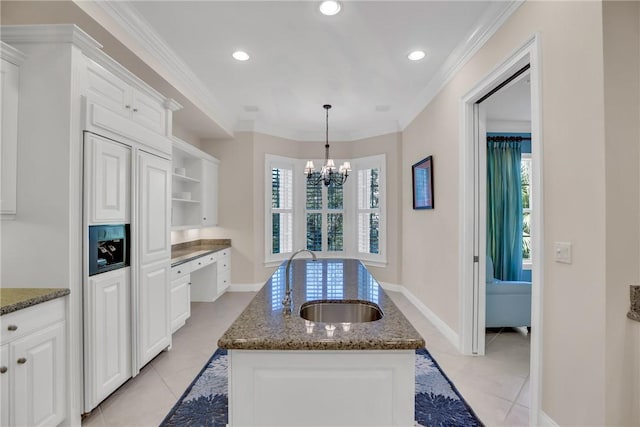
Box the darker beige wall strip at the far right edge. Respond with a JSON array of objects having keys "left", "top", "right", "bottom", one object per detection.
[{"left": 603, "top": 1, "right": 640, "bottom": 425}]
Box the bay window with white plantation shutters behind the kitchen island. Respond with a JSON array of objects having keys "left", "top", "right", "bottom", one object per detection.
[{"left": 265, "top": 155, "right": 386, "bottom": 266}]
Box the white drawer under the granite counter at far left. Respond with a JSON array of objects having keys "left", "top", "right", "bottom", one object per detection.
[{"left": 0, "top": 297, "right": 65, "bottom": 344}]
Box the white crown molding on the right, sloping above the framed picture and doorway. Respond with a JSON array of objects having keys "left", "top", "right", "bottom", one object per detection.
[{"left": 398, "top": 0, "right": 525, "bottom": 130}]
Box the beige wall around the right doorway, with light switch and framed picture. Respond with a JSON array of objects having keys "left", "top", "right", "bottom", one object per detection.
[{"left": 402, "top": 2, "right": 620, "bottom": 425}]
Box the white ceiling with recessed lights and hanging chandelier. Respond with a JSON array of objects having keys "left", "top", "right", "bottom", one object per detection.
[{"left": 109, "top": 1, "right": 514, "bottom": 140}]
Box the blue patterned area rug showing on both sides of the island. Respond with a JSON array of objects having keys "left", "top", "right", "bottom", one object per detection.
[{"left": 160, "top": 348, "right": 483, "bottom": 427}]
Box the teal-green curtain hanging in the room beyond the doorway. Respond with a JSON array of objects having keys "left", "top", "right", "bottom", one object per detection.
[{"left": 487, "top": 141, "right": 522, "bottom": 280}]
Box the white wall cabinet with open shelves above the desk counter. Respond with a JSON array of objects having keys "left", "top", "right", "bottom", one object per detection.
[{"left": 171, "top": 137, "right": 219, "bottom": 230}]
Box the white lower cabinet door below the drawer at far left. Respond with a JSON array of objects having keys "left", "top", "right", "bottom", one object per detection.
[{"left": 9, "top": 322, "right": 66, "bottom": 426}]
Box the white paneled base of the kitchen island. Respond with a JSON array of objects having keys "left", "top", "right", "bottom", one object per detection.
[{"left": 228, "top": 350, "right": 415, "bottom": 426}]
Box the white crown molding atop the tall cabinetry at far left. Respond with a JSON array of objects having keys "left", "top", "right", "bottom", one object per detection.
[{"left": 0, "top": 24, "right": 102, "bottom": 51}]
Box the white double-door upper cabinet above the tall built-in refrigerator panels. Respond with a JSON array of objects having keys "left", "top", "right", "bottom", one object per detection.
[{"left": 87, "top": 60, "right": 167, "bottom": 134}]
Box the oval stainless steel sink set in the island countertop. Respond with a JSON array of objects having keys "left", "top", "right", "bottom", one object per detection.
[{"left": 300, "top": 301, "right": 383, "bottom": 323}]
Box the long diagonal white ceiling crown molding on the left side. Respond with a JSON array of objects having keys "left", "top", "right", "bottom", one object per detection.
[{"left": 85, "top": 0, "right": 233, "bottom": 135}]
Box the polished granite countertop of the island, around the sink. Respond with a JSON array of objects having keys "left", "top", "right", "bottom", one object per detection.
[{"left": 218, "top": 259, "right": 425, "bottom": 350}]
